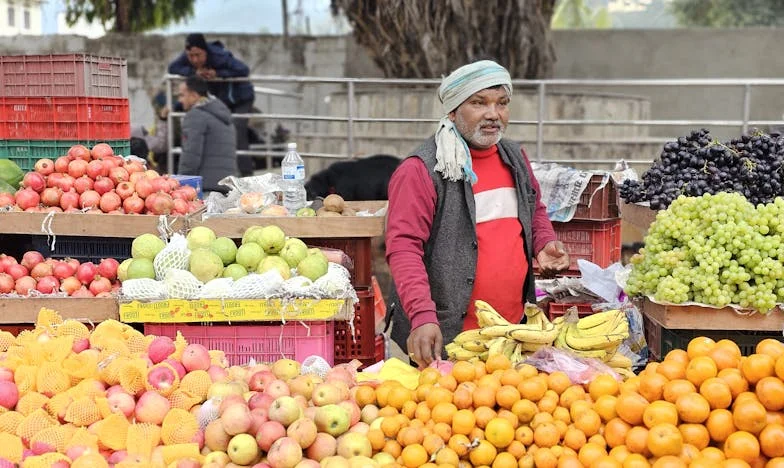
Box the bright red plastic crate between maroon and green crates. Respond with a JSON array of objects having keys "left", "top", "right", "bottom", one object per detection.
[{"left": 0, "top": 97, "right": 131, "bottom": 140}]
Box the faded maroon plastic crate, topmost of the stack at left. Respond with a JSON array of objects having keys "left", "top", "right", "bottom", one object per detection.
[{"left": 0, "top": 54, "right": 128, "bottom": 98}]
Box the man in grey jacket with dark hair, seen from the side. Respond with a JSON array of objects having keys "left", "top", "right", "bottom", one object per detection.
[{"left": 177, "top": 76, "right": 237, "bottom": 193}]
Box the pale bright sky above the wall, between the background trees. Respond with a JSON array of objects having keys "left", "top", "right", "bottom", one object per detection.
[{"left": 42, "top": 0, "right": 330, "bottom": 34}]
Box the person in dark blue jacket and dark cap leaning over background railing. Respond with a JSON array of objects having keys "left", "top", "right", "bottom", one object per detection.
[{"left": 169, "top": 33, "right": 255, "bottom": 176}]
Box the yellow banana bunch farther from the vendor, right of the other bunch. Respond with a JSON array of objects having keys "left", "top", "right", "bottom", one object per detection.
[{"left": 555, "top": 310, "right": 634, "bottom": 378}]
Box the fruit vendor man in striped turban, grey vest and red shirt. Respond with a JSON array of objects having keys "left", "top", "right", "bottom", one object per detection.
[{"left": 386, "top": 60, "right": 569, "bottom": 366}]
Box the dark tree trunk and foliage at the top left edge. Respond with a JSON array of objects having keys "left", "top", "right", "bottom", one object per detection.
[{"left": 65, "top": 0, "right": 195, "bottom": 33}]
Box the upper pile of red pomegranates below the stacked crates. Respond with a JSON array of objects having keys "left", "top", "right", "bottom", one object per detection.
[{"left": 0, "top": 143, "right": 203, "bottom": 215}]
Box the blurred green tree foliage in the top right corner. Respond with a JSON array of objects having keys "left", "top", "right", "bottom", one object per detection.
[{"left": 670, "top": 0, "right": 784, "bottom": 28}]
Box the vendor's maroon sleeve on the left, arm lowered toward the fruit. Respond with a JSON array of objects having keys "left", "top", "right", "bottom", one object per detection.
[{"left": 386, "top": 158, "right": 438, "bottom": 330}]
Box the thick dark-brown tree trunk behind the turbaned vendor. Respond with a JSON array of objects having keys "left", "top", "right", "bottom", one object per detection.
[{"left": 332, "top": 0, "right": 555, "bottom": 79}]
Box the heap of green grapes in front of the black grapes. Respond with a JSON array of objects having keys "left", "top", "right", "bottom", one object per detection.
[{"left": 626, "top": 192, "right": 784, "bottom": 313}]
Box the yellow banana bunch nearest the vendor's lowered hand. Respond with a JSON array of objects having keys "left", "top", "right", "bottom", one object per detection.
[{"left": 445, "top": 301, "right": 564, "bottom": 363}]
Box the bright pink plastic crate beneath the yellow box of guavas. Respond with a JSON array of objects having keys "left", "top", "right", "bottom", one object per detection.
[{"left": 144, "top": 322, "right": 335, "bottom": 365}]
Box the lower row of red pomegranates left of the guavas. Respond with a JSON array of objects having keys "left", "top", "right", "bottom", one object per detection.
[{"left": 0, "top": 250, "right": 120, "bottom": 297}]
